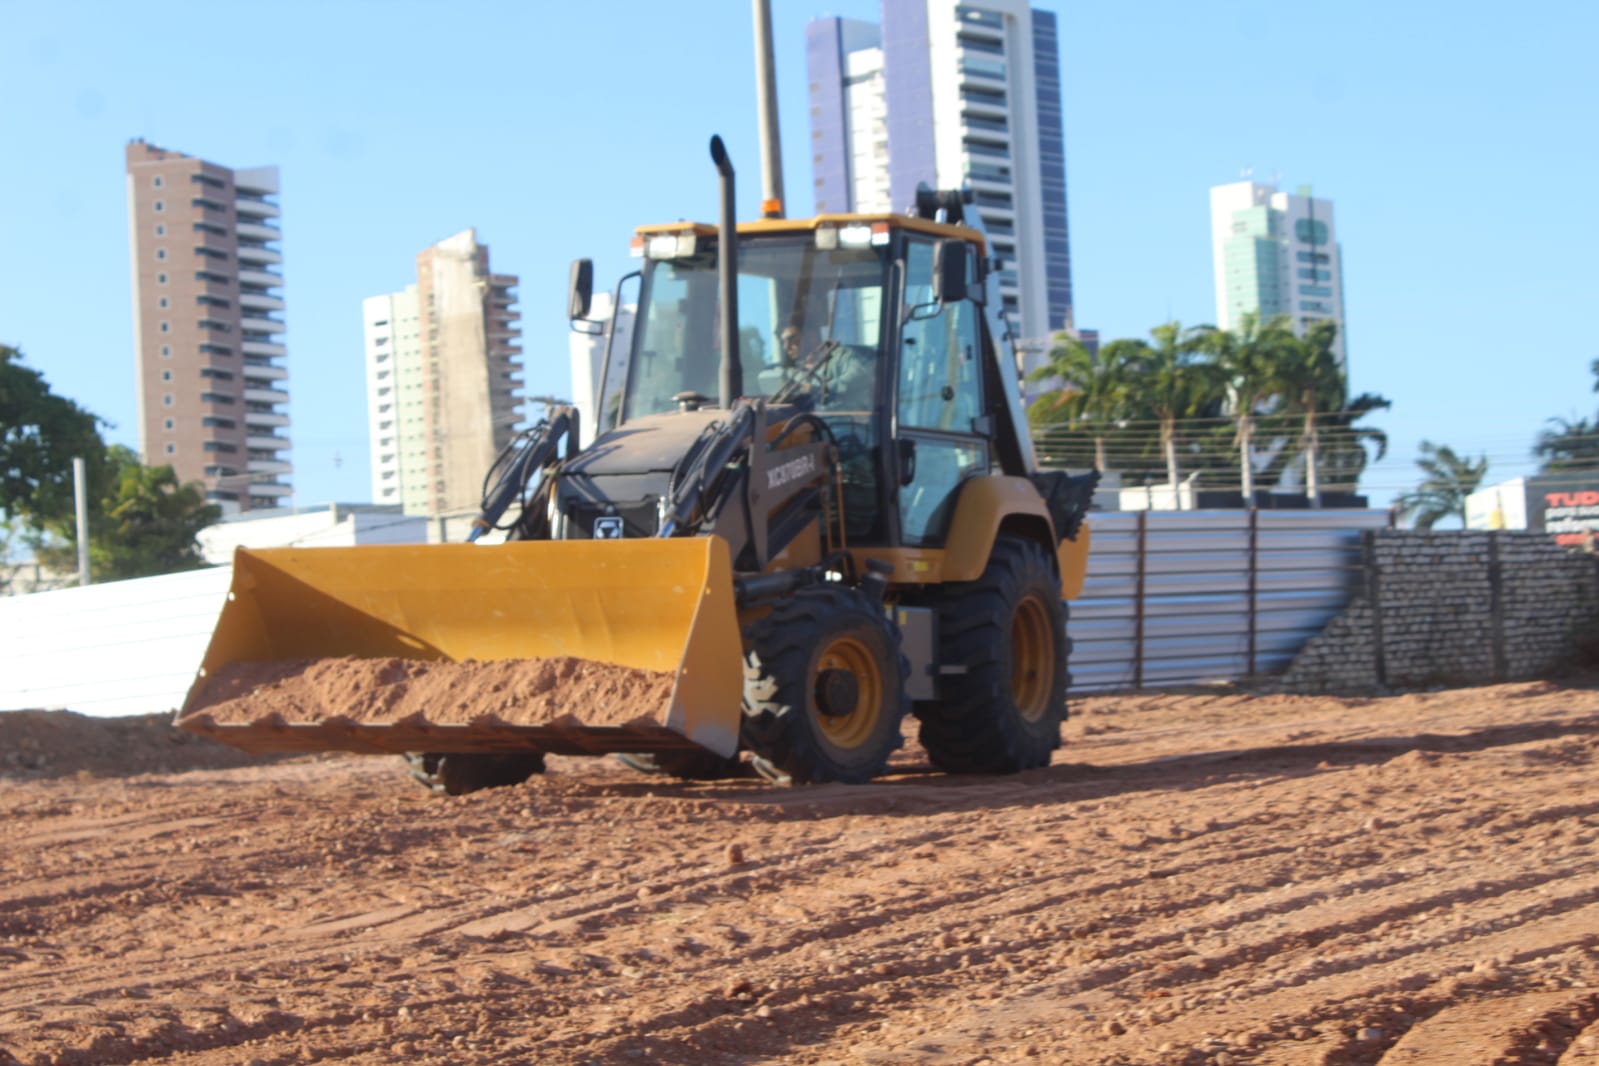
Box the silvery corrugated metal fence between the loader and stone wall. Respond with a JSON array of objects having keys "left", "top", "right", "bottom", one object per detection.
[{"left": 1067, "top": 510, "right": 1388, "bottom": 690}]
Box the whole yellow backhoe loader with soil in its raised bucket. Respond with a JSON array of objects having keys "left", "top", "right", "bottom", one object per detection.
[{"left": 177, "top": 137, "right": 1099, "bottom": 793}]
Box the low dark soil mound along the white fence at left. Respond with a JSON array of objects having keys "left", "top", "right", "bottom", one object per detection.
[{"left": 0, "top": 711, "right": 281, "bottom": 778}]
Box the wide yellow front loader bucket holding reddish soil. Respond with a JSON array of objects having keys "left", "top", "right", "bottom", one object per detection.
[{"left": 177, "top": 537, "right": 742, "bottom": 754}]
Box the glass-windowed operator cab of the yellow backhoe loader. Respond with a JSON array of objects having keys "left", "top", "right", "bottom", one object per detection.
[{"left": 572, "top": 214, "right": 1020, "bottom": 547}]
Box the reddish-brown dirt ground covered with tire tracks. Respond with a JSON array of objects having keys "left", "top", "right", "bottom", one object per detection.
[{"left": 0, "top": 682, "right": 1599, "bottom": 1066}]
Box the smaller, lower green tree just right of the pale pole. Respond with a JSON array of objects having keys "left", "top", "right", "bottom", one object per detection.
[{"left": 38, "top": 444, "right": 222, "bottom": 580}]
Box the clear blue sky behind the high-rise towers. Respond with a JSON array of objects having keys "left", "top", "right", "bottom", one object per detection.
[{"left": 0, "top": 0, "right": 1599, "bottom": 507}]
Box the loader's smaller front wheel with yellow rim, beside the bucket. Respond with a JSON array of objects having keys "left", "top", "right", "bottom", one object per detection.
[{"left": 742, "top": 587, "right": 910, "bottom": 783}]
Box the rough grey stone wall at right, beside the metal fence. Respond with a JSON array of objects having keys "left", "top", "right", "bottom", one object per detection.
[{"left": 1281, "top": 529, "right": 1599, "bottom": 692}]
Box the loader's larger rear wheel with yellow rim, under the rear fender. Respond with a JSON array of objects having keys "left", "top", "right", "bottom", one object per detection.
[{"left": 916, "top": 534, "right": 1070, "bottom": 774}]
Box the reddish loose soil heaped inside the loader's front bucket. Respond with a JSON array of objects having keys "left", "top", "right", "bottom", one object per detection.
[{"left": 183, "top": 657, "right": 673, "bottom": 726}]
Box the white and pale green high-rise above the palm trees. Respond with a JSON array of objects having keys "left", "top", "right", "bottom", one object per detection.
[{"left": 1210, "top": 181, "right": 1345, "bottom": 366}]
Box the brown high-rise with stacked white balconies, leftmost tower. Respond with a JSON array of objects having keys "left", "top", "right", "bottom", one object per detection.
[{"left": 126, "top": 141, "right": 293, "bottom": 511}]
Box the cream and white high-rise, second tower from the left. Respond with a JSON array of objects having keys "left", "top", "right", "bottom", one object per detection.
[{"left": 361, "top": 230, "right": 521, "bottom": 515}]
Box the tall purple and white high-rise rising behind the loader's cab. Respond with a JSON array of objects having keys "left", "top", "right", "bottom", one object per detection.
[{"left": 806, "top": 0, "right": 1073, "bottom": 363}]
